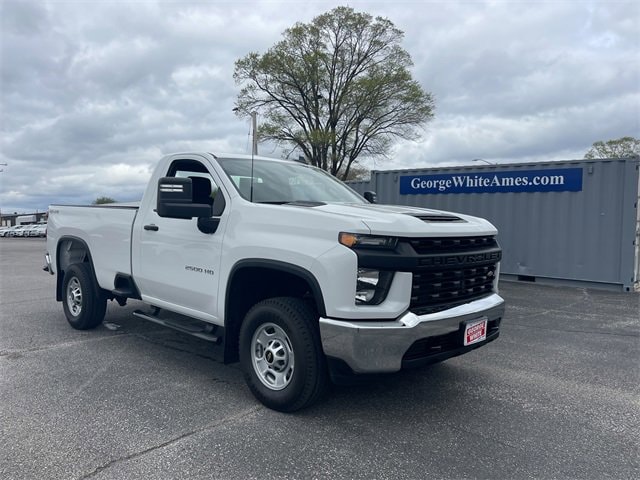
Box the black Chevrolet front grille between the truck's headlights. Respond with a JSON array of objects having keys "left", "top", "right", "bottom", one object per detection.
[{"left": 409, "top": 236, "right": 501, "bottom": 315}]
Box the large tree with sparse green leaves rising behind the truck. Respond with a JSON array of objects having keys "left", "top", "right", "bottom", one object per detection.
[{"left": 233, "top": 7, "right": 434, "bottom": 178}]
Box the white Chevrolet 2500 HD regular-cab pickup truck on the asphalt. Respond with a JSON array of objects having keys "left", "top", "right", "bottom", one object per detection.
[{"left": 45, "top": 153, "right": 504, "bottom": 411}]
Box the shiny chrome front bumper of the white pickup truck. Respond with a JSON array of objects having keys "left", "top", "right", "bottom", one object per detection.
[{"left": 320, "top": 294, "right": 504, "bottom": 373}]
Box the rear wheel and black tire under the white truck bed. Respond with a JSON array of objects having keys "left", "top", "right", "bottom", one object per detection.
[{"left": 62, "top": 263, "right": 107, "bottom": 330}]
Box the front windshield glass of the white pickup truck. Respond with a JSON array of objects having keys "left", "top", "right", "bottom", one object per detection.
[{"left": 218, "top": 158, "right": 367, "bottom": 203}]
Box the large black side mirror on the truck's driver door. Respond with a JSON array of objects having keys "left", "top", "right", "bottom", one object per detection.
[{"left": 156, "top": 177, "right": 211, "bottom": 219}]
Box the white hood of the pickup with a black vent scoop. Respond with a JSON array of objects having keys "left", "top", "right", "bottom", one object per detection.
[{"left": 313, "top": 204, "right": 497, "bottom": 237}]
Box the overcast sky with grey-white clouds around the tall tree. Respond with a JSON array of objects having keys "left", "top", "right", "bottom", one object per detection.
[{"left": 0, "top": 0, "right": 640, "bottom": 213}]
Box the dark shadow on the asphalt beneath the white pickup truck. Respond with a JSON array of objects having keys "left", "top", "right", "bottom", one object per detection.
[{"left": 96, "top": 302, "right": 496, "bottom": 416}]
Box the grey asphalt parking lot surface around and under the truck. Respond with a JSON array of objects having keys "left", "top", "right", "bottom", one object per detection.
[{"left": 0, "top": 238, "right": 640, "bottom": 479}]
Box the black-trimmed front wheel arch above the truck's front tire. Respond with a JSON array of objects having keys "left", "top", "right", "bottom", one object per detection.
[{"left": 224, "top": 259, "right": 326, "bottom": 363}]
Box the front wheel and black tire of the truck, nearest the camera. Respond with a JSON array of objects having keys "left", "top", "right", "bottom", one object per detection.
[{"left": 240, "top": 297, "right": 328, "bottom": 412}]
